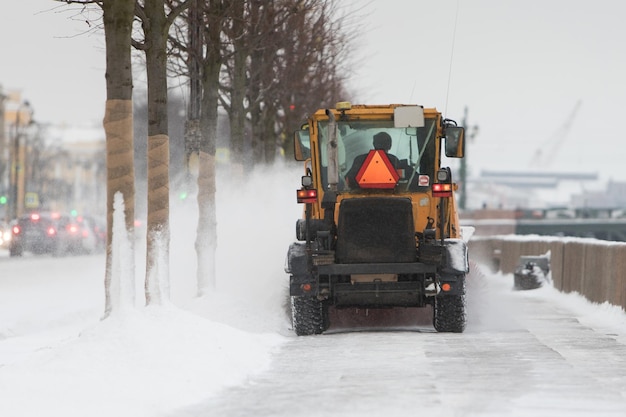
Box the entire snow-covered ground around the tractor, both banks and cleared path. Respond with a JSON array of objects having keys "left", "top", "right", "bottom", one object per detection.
[{"left": 0, "top": 247, "right": 626, "bottom": 417}]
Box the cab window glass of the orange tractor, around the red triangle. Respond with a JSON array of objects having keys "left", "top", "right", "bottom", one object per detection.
[{"left": 318, "top": 119, "right": 437, "bottom": 191}]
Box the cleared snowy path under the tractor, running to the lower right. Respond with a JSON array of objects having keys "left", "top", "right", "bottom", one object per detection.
[{"left": 172, "top": 268, "right": 626, "bottom": 417}]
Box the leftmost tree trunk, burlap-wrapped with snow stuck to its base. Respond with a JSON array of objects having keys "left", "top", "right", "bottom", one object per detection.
[{"left": 102, "top": 0, "right": 135, "bottom": 318}]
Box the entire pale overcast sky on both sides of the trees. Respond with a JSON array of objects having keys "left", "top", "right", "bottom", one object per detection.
[{"left": 0, "top": 0, "right": 626, "bottom": 180}]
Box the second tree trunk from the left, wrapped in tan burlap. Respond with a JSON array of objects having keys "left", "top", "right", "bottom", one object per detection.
[{"left": 142, "top": 0, "right": 170, "bottom": 305}]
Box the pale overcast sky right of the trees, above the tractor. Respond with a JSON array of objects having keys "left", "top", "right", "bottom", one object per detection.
[{"left": 346, "top": 0, "right": 626, "bottom": 180}]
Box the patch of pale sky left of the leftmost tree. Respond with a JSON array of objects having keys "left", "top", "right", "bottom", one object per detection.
[{"left": 0, "top": 0, "right": 106, "bottom": 124}]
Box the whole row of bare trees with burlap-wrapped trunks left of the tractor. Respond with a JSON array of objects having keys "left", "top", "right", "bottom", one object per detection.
[{"left": 62, "top": 0, "right": 356, "bottom": 316}]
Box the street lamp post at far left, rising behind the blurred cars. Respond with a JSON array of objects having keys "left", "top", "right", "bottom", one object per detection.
[{"left": 10, "top": 101, "right": 32, "bottom": 219}]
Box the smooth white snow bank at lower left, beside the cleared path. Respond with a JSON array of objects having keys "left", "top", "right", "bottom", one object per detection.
[{"left": 0, "top": 307, "right": 281, "bottom": 417}]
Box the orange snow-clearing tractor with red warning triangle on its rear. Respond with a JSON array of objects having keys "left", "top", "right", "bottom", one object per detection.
[{"left": 286, "top": 102, "right": 468, "bottom": 335}]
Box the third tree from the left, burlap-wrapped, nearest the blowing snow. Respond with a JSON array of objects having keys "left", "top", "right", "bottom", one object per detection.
[{"left": 170, "top": 0, "right": 230, "bottom": 296}]
